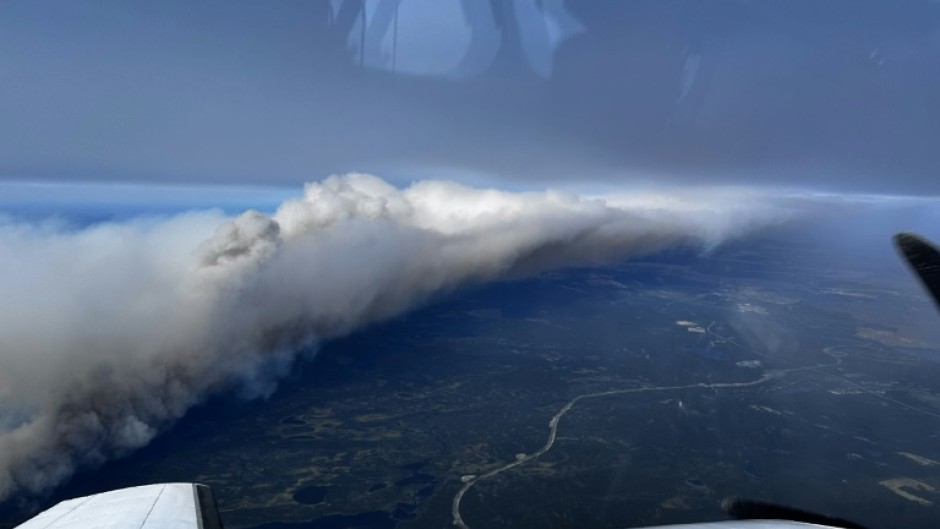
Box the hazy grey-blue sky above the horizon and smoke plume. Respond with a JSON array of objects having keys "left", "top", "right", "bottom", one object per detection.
[{"left": 0, "top": 0, "right": 940, "bottom": 194}]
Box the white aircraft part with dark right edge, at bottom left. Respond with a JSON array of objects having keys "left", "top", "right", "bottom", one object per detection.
[{"left": 16, "top": 483, "right": 222, "bottom": 529}]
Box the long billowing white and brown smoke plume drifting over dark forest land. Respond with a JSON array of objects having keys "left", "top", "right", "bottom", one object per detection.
[{"left": 0, "top": 174, "right": 784, "bottom": 499}]
